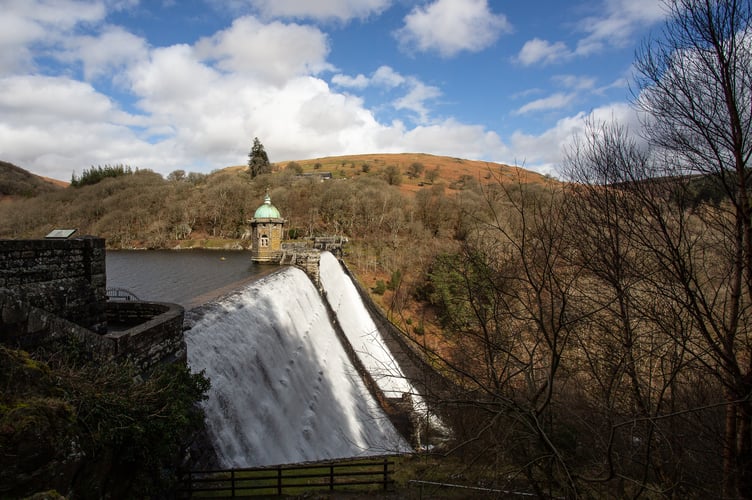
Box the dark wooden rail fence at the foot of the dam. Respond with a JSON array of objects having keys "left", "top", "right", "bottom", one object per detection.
[{"left": 176, "top": 458, "right": 394, "bottom": 498}]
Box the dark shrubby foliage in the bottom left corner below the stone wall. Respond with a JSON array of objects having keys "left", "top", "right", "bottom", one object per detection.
[{"left": 0, "top": 346, "right": 209, "bottom": 498}]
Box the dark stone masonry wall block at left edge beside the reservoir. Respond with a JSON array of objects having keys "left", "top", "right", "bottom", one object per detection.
[{"left": 0, "top": 236, "right": 107, "bottom": 333}]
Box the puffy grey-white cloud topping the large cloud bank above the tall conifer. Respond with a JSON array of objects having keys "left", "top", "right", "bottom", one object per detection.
[{"left": 196, "top": 16, "right": 331, "bottom": 85}]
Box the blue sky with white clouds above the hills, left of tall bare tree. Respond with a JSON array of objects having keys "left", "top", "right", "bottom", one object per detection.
[{"left": 0, "top": 0, "right": 665, "bottom": 180}]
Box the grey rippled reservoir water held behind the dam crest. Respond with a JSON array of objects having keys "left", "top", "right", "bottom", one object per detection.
[{"left": 106, "top": 250, "right": 278, "bottom": 309}]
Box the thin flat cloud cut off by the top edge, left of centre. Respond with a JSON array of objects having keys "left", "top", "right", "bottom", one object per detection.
[{"left": 250, "top": 0, "right": 392, "bottom": 22}]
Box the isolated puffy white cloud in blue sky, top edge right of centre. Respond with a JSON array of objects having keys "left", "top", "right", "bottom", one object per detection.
[{"left": 395, "top": 0, "right": 511, "bottom": 57}]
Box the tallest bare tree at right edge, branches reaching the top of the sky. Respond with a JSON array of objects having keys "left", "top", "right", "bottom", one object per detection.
[{"left": 636, "top": 0, "right": 752, "bottom": 497}]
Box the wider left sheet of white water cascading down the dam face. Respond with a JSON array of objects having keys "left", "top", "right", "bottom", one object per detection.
[{"left": 185, "top": 266, "right": 409, "bottom": 467}]
